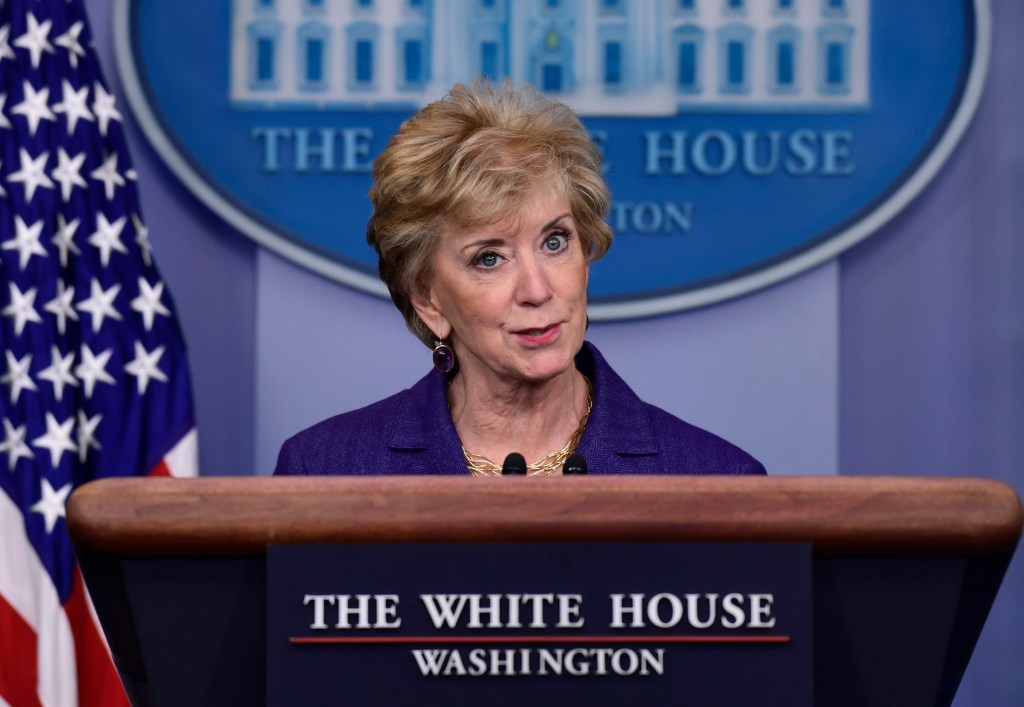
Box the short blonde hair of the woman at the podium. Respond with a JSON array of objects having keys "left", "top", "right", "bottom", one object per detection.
[{"left": 367, "top": 81, "right": 611, "bottom": 346}]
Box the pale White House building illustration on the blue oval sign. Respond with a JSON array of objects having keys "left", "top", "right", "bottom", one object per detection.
[{"left": 230, "top": 0, "right": 870, "bottom": 116}]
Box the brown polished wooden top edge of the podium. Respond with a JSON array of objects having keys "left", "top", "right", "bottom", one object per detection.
[{"left": 68, "top": 476, "right": 1022, "bottom": 556}]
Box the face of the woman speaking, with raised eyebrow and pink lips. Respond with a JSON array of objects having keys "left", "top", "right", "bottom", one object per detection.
[{"left": 414, "top": 183, "right": 588, "bottom": 383}]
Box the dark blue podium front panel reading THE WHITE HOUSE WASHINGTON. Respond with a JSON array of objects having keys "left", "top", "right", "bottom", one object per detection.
[{"left": 266, "top": 543, "right": 814, "bottom": 707}]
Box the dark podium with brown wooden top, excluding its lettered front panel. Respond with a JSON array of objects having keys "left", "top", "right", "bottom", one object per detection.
[{"left": 68, "top": 476, "right": 1022, "bottom": 706}]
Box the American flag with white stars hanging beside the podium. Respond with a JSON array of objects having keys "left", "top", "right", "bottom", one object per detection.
[{"left": 0, "top": 0, "right": 197, "bottom": 707}]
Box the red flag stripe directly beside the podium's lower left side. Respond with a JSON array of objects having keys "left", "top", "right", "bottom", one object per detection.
[{"left": 65, "top": 568, "right": 128, "bottom": 707}]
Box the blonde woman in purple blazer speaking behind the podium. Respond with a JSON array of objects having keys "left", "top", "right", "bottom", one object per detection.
[{"left": 274, "top": 82, "right": 765, "bottom": 475}]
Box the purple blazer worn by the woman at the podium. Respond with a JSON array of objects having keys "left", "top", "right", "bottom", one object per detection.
[{"left": 274, "top": 342, "right": 765, "bottom": 475}]
